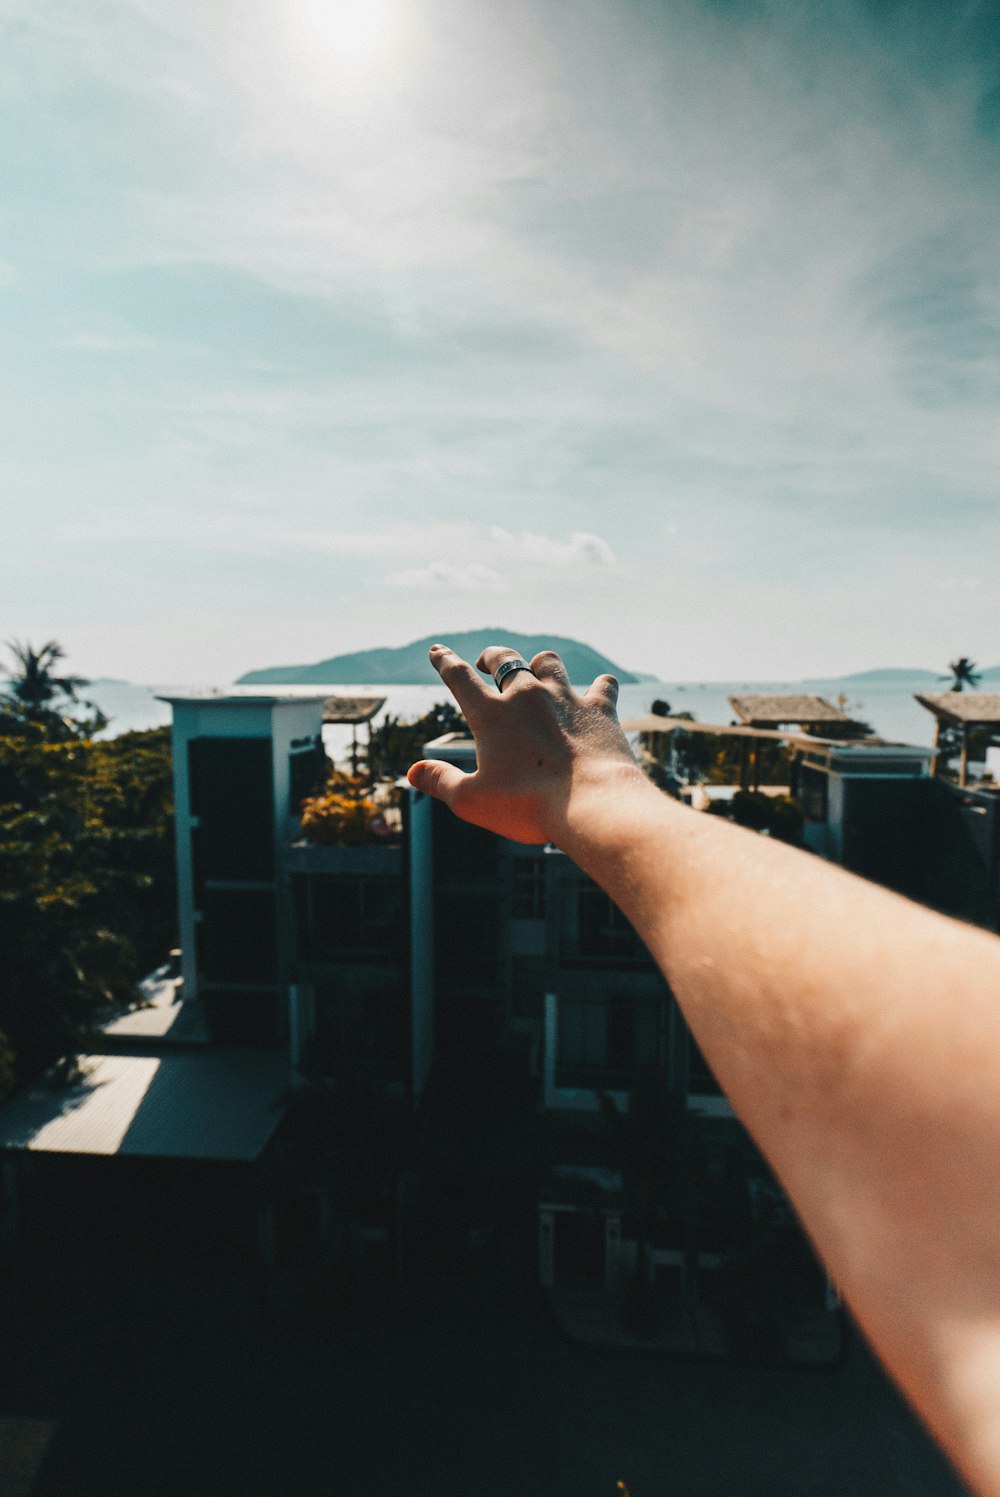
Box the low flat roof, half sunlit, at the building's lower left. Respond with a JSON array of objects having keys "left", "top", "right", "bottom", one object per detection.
[{"left": 0, "top": 1046, "right": 289, "bottom": 1163}]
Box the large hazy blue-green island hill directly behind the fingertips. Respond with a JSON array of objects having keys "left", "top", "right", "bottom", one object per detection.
[{"left": 237, "top": 629, "right": 636, "bottom": 686}]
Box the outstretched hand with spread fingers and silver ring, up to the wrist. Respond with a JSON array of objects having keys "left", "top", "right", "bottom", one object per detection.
[{"left": 409, "top": 645, "right": 642, "bottom": 844}]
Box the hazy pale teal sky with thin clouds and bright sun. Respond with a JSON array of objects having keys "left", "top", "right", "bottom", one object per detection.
[{"left": 0, "top": 0, "right": 1000, "bottom": 684}]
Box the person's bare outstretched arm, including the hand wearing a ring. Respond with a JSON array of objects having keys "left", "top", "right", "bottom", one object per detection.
[{"left": 410, "top": 645, "right": 1000, "bottom": 1497}]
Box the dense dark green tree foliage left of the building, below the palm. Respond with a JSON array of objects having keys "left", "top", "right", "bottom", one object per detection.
[{"left": 0, "top": 717, "right": 177, "bottom": 1088}]
